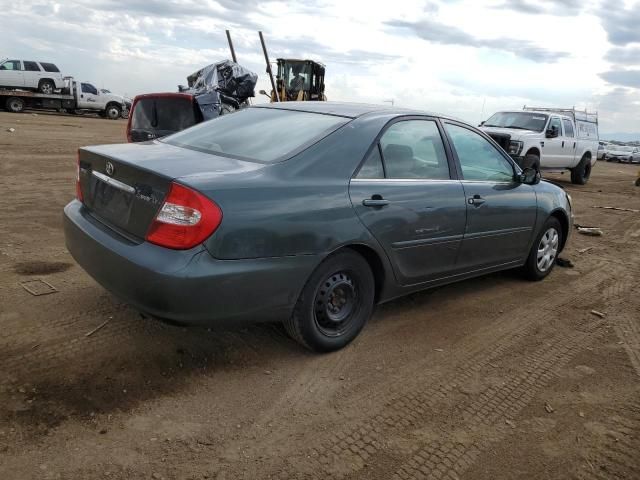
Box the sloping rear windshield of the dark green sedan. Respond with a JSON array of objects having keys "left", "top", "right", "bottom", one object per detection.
[{"left": 163, "top": 108, "right": 350, "bottom": 163}]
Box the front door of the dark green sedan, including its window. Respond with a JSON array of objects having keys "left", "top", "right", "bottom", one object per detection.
[{"left": 445, "top": 122, "right": 537, "bottom": 272}]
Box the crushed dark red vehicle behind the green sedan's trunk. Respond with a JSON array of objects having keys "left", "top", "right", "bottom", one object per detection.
[{"left": 127, "top": 60, "right": 258, "bottom": 142}]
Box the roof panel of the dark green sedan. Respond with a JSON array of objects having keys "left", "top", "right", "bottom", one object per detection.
[{"left": 254, "top": 102, "right": 455, "bottom": 120}]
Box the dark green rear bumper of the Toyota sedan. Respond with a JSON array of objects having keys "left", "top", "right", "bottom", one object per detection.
[{"left": 63, "top": 200, "right": 319, "bottom": 326}]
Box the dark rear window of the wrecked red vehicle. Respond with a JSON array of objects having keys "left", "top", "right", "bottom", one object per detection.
[{"left": 131, "top": 97, "right": 196, "bottom": 132}]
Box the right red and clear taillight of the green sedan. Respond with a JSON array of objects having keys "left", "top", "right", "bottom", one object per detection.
[{"left": 146, "top": 183, "right": 222, "bottom": 250}]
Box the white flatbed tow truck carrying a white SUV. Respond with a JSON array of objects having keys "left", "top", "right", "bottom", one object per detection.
[{"left": 0, "top": 77, "right": 126, "bottom": 120}]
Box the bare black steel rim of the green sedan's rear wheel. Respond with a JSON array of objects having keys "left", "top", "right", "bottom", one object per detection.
[{"left": 314, "top": 272, "right": 358, "bottom": 337}]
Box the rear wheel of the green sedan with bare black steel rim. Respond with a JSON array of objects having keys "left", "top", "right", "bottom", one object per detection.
[{"left": 283, "top": 251, "right": 375, "bottom": 352}]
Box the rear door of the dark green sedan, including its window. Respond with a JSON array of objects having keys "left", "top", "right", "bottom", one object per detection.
[{"left": 350, "top": 117, "right": 466, "bottom": 285}]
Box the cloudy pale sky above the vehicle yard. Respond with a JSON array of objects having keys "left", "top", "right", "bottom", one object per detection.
[{"left": 0, "top": 0, "right": 640, "bottom": 133}]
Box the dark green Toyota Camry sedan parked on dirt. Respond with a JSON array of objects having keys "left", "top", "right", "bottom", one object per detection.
[{"left": 64, "top": 102, "right": 572, "bottom": 351}]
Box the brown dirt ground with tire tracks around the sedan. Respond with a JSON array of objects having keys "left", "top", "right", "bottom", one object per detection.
[{"left": 0, "top": 113, "right": 640, "bottom": 480}]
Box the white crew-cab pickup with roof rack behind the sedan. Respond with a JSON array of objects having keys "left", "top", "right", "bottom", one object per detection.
[{"left": 480, "top": 107, "right": 598, "bottom": 185}]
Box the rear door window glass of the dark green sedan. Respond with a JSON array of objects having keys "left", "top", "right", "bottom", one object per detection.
[{"left": 380, "top": 120, "right": 450, "bottom": 180}]
